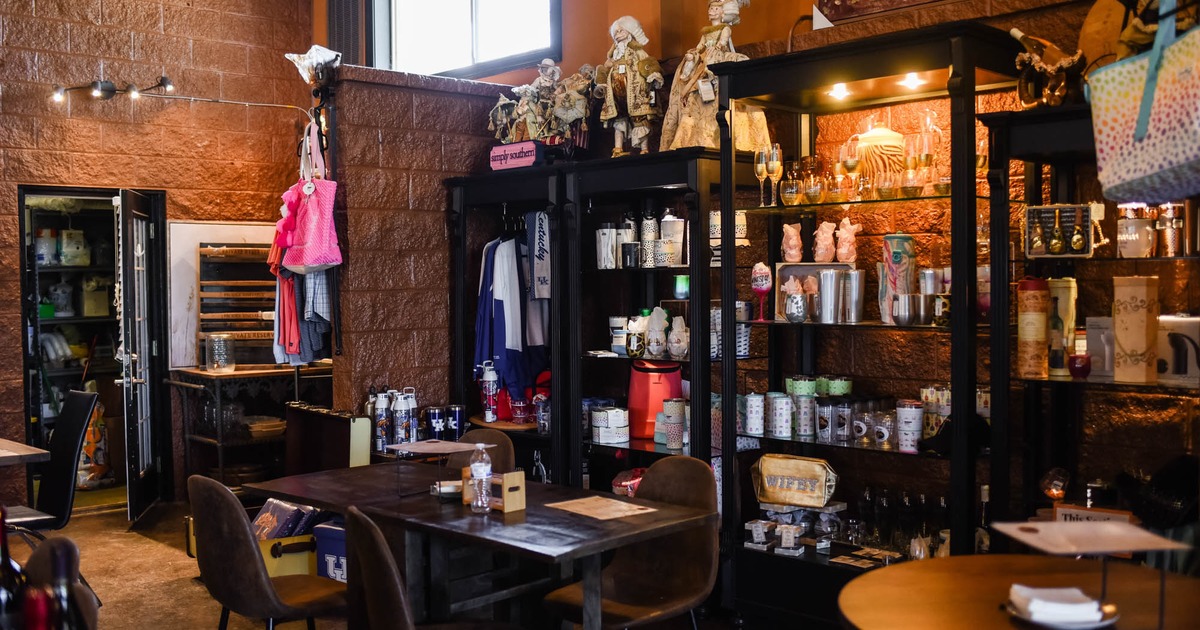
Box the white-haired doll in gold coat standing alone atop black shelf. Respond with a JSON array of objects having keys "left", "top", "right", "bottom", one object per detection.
[{"left": 594, "top": 16, "right": 662, "bottom": 157}]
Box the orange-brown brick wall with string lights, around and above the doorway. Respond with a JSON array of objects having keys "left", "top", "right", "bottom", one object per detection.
[{"left": 0, "top": 0, "right": 312, "bottom": 502}]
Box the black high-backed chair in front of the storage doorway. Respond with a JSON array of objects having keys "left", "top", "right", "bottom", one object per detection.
[{"left": 7, "top": 390, "right": 98, "bottom": 547}]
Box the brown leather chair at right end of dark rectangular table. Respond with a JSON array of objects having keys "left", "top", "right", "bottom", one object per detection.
[{"left": 545, "top": 455, "right": 718, "bottom": 628}]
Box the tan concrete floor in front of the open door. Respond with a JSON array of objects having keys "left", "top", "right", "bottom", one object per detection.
[{"left": 10, "top": 503, "right": 732, "bottom": 630}]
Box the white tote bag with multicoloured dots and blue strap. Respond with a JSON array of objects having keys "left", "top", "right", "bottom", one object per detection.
[{"left": 1087, "top": 0, "right": 1200, "bottom": 204}]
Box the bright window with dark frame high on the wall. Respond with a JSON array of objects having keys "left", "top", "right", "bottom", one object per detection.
[{"left": 391, "top": 0, "right": 562, "bottom": 78}]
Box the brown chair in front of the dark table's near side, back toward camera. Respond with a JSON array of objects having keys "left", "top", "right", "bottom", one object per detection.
[{"left": 346, "top": 505, "right": 512, "bottom": 630}]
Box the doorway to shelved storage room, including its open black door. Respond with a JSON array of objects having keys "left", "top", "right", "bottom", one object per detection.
[{"left": 17, "top": 186, "right": 172, "bottom": 520}]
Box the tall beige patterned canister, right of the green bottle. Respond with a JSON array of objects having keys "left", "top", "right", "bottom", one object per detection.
[{"left": 1112, "top": 276, "right": 1159, "bottom": 383}]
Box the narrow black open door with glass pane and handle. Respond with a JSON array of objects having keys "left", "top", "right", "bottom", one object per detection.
[{"left": 113, "top": 190, "right": 170, "bottom": 521}]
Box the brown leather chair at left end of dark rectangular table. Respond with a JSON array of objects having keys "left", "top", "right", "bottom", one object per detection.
[{"left": 187, "top": 475, "right": 346, "bottom": 630}]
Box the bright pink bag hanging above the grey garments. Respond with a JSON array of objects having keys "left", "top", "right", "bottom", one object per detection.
[{"left": 283, "top": 122, "right": 342, "bottom": 274}]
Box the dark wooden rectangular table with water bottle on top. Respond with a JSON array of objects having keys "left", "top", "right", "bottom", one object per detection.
[{"left": 242, "top": 461, "right": 718, "bottom": 630}]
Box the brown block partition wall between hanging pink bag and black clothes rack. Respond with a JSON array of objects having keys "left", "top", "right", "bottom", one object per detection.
[{"left": 334, "top": 66, "right": 505, "bottom": 409}]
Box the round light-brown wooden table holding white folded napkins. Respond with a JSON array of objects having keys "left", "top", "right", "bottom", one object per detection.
[{"left": 838, "top": 554, "right": 1200, "bottom": 630}]
